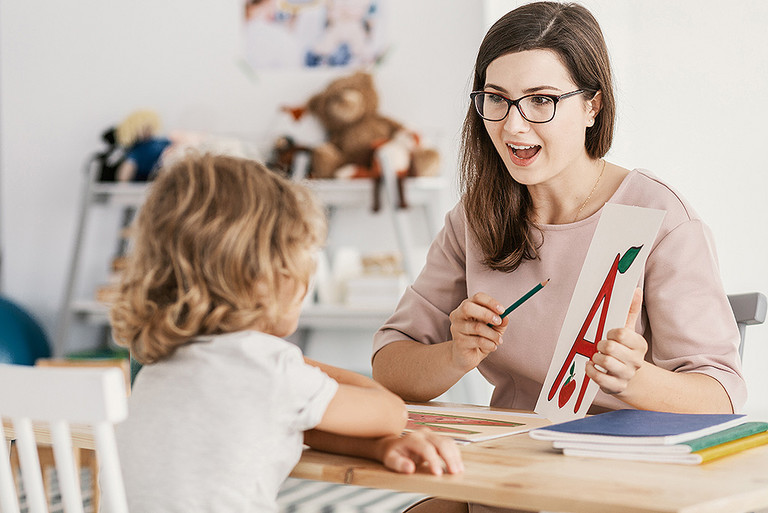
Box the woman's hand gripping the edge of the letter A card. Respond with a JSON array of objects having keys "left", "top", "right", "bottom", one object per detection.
[{"left": 585, "top": 288, "right": 648, "bottom": 394}]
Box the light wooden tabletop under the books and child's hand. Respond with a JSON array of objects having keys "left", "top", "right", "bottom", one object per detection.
[{"left": 291, "top": 408, "right": 768, "bottom": 513}]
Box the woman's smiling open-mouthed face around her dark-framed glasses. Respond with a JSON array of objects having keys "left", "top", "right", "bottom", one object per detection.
[{"left": 483, "top": 50, "right": 600, "bottom": 186}]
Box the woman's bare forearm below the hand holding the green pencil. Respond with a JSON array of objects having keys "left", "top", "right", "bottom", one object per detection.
[{"left": 373, "top": 340, "right": 467, "bottom": 402}]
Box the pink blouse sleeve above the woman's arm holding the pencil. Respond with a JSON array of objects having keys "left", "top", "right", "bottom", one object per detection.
[{"left": 373, "top": 203, "right": 467, "bottom": 355}]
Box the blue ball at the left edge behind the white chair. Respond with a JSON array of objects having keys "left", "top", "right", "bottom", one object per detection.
[{"left": 0, "top": 297, "right": 51, "bottom": 365}]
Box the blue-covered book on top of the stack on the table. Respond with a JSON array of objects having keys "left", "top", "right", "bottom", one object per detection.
[{"left": 529, "top": 410, "right": 746, "bottom": 445}]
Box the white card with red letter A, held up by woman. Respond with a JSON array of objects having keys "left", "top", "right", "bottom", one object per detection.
[{"left": 534, "top": 203, "right": 665, "bottom": 422}]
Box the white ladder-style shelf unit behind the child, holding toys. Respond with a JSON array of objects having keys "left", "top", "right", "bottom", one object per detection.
[{"left": 54, "top": 165, "right": 445, "bottom": 356}]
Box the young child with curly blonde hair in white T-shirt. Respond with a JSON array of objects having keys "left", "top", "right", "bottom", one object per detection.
[{"left": 111, "top": 155, "right": 462, "bottom": 512}]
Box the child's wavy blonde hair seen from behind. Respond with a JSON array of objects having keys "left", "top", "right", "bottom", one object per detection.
[{"left": 110, "top": 155, "right": 326, "bottom": 364}]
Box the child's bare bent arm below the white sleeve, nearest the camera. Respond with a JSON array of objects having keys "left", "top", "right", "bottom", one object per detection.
[{"left": 304, "top": 358, "right": 408, "bottom": 438}]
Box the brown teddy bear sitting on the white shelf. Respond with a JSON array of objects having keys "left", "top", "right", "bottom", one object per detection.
[{"left": 296, "top": 72, "right": 439, "bottom": 211}]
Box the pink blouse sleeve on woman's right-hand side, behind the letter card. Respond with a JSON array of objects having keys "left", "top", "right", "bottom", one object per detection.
[{"left": 644, "top": 219, "right": 747, "bottom": 411}]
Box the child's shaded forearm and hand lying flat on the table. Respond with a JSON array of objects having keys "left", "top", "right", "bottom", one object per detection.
[{"left": 304, "top": 429, "right": 464, "bottom": 475}]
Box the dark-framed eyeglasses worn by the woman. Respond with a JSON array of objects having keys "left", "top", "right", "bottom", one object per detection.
[{"left": 469, "top": 89, "right": 584, "bottom": 123}]
